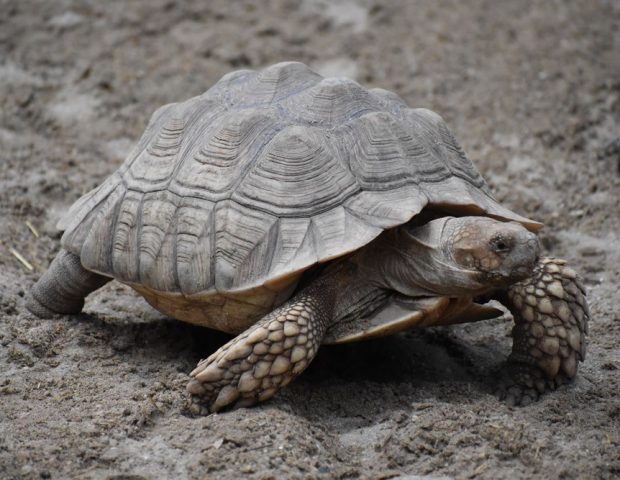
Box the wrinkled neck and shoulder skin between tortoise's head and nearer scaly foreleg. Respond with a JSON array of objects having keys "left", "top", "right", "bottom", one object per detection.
[{"left": 314, "top": 217, "right": 504, "bottom": 322}]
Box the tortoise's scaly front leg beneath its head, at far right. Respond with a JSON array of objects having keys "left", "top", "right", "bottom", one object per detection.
[{"left": 501, "top": 258, "right": 590, "bottom": 405}]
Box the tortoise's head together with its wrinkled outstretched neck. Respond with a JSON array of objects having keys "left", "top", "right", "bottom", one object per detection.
[{"left": 374, "top": 217, "right": 540, "bottom": 297}]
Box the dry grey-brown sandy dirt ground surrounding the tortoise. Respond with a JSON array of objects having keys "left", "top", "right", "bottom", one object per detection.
[{"left": 0, "top": 0, "right": 620, "bottom": 479}]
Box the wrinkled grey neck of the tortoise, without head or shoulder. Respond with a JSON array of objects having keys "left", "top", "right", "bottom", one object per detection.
[{"left": 358, "top": 217, "right": 489, "bottom": 298}]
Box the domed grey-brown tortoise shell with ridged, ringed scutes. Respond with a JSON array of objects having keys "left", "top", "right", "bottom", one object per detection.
[{"left": 59, "top": 62, "right": 538, "bottom": 333}]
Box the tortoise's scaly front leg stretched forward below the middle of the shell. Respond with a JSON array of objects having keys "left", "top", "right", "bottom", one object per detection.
[{"left": 187, "top": 291, "right": 331, "bottom": 412}]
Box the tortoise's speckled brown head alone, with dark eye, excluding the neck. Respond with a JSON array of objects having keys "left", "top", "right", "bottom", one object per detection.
[{"left": 441, "top": 217, "right": 540, "bottom": 288}]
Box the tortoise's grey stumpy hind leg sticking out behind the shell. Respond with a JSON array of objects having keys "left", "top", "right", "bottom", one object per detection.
[{"left": 26, "top": 250, "right": 110, "bottom": 318}]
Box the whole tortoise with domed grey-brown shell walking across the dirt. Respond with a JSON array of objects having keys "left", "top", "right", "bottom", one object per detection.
[{"left": 27, "top": 62, "right": 589, "bottom": 411}]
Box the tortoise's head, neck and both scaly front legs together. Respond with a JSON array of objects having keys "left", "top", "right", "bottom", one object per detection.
[{"left": 188, "top": 217, "right": 588, "bottom": 411}]
